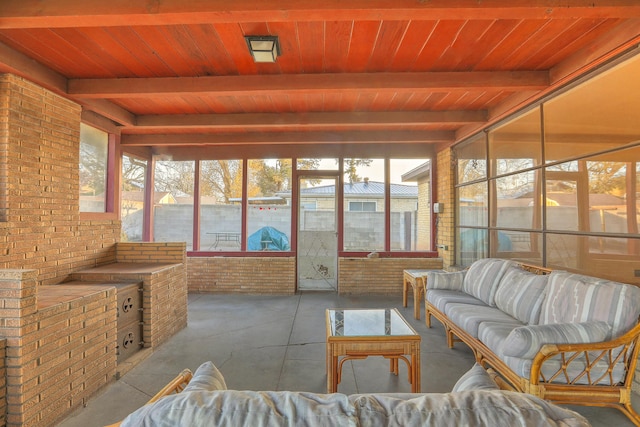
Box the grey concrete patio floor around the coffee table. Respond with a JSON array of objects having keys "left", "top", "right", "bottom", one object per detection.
[{"left": 58, "top": 293, "right": 640, "bottom": 427}]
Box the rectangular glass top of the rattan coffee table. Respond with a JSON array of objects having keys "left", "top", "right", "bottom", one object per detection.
[{"left": 327, "top": 308, "right": 417, "bottom": 337}]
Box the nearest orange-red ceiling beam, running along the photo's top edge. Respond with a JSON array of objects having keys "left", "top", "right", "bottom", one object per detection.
[{"left": 0, "top": 0, "right": 640, "bottom": 29}]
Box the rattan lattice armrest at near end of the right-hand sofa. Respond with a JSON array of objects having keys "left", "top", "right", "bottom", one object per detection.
[{"left": 530, "top": 324, "right": 640, "bottom": 386}]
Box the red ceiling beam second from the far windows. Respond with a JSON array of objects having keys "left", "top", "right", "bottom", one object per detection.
[{"left": 132, "top": 110, "right": 487, "bottom": 133}]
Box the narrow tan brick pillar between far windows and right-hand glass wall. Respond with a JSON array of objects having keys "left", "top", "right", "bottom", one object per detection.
[{"left": 434, "top": 148, "right": 456, "bottom": 270}]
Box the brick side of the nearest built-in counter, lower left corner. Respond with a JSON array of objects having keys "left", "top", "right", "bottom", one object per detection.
[{"left": 0, "top": 270, "right": 117, "bottom": 426}]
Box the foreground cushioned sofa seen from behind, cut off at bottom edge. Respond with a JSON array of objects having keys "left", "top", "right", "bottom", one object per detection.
[{"left": 109, "top": 362, "right": 590, "bottom": 427}]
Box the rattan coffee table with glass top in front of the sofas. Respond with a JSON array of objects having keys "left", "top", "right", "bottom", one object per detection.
[{"left": 326, "top": 308, "right": 420, "bottom": 393}]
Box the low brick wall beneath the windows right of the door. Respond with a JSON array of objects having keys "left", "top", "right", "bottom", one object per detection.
[{"left": 338, "top": 258, "right": 442, "bottom": 297}]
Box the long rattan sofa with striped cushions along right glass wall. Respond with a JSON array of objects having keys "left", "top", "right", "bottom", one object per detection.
[{"left": 425, "top": 258, "right": 640, "bottom": 425}]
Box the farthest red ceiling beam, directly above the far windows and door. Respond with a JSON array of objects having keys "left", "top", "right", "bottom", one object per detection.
[{"left": 120, "top": 131, "right": 454, "bottom": 146}]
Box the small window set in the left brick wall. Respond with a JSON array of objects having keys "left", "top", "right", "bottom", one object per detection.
[{"left": 80, "top": 123, "right": 109, "bottom": 212}]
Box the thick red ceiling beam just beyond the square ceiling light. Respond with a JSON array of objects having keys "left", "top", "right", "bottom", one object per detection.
[{"left": 68, "top": 71, "right": 549, "bottom": 98}]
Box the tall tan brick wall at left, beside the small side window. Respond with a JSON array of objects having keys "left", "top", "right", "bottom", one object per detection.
[{"left": 0, "top": 74, "right": 120, "bottom": 285}]
